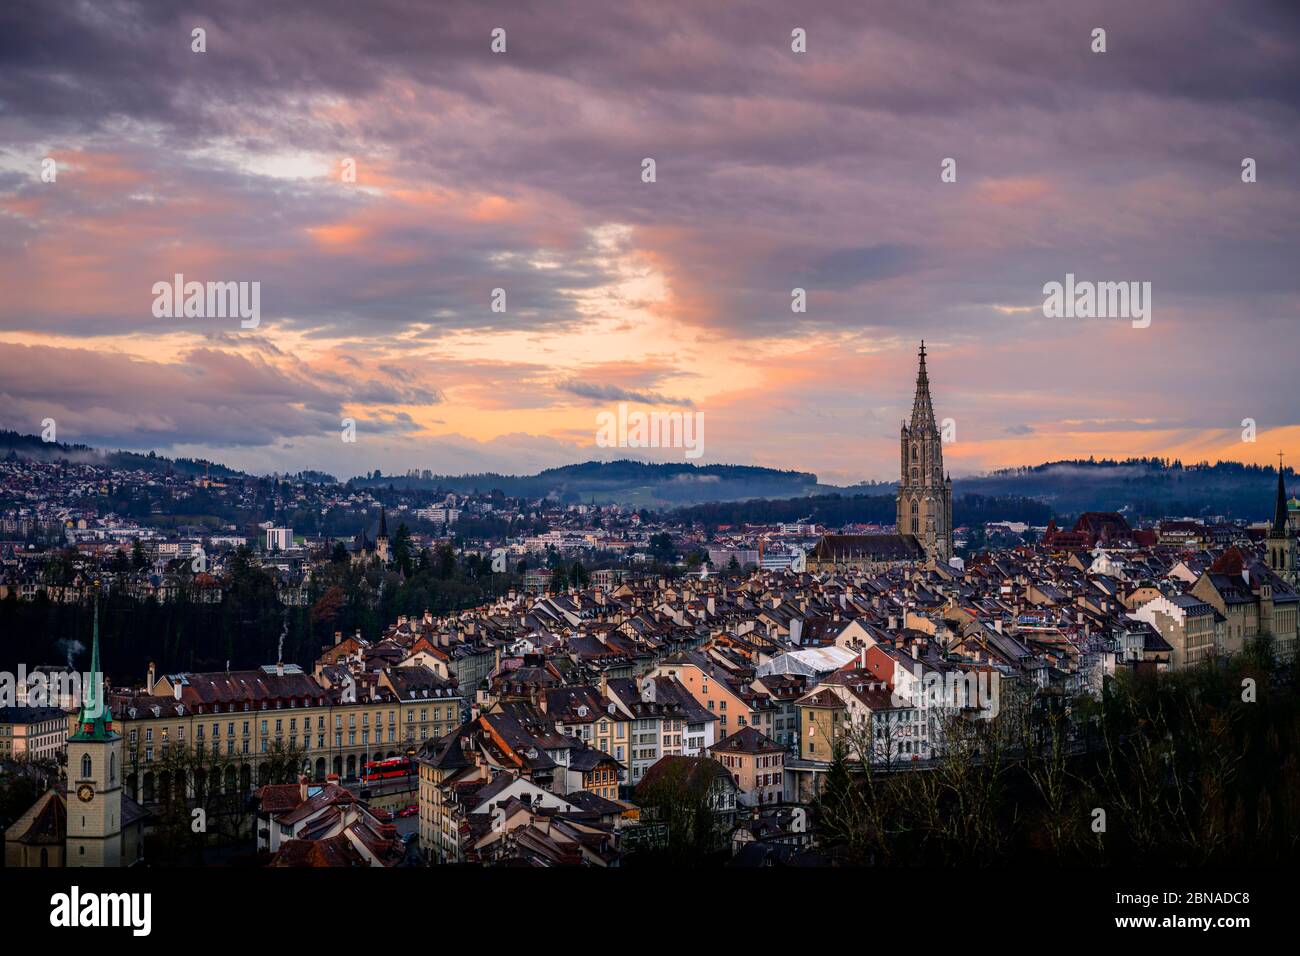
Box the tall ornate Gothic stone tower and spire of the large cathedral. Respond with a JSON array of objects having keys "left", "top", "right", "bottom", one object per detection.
[{"left": 897, "top": 342, "right": 953, "bottom": 563}]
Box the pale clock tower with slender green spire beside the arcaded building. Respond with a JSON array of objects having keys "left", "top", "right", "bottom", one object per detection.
[{"left": 65, "top": 583, "right": 122, "bottom": 866}]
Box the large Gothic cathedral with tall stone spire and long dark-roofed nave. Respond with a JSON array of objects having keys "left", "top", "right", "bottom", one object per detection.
[{"left": 807, "top": 342, "right": 953, "bottom": 571}]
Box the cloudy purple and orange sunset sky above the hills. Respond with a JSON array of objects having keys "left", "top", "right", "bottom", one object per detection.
[{"left": 0, "top": 0, "right": 1300, "bottom": 484}]
